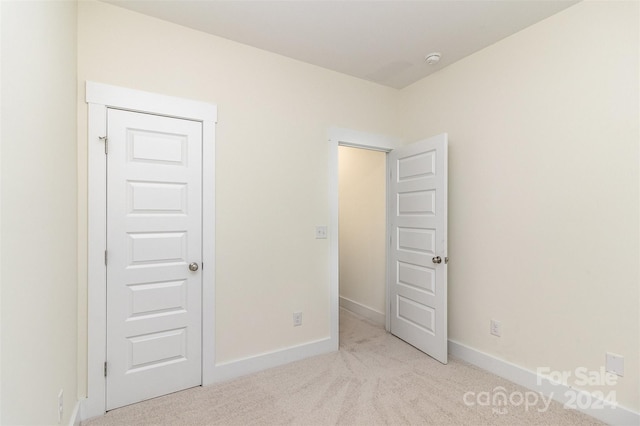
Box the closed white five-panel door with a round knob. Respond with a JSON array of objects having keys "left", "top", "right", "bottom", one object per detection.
[{"left": 106, "top": 109, "right": 202, "bottom": 410}]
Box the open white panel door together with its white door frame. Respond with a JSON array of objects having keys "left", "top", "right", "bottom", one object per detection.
[{"left": 329, "top": 129, "right": 448, "bottom": 364}]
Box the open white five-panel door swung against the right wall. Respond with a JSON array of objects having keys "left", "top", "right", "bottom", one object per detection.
[{"left": 388, "top": 134, "right": 447, "bottom": 364}]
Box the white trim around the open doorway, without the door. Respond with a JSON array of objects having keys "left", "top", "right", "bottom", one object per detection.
[{"left": 329, "top": 128, "right": 403, "bottom": 338}]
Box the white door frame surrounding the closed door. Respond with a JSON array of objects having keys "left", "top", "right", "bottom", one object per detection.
[{"left": 83, "top": 81, "right": 217, "bottom": 418}]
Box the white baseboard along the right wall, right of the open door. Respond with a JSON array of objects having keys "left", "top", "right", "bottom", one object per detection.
[{"left": 449, "top": 340, "right": 640, "bottom": 426}]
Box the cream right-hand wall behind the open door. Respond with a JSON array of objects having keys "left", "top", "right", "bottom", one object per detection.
[{"left": 401, "top": 1, "right": 640, "bottom": 411}]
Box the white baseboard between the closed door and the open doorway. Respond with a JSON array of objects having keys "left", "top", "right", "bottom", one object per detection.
[{"left": 210, "top": 337, "right": 338, "bottom": 386}]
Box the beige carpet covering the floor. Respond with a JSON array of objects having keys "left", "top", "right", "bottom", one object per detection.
[{"left": 83, "top": 310, "right": 602, "bottom": 426}]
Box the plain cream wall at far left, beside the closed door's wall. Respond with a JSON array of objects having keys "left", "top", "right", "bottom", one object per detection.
[{"left": 0, "top": 1, "right": 78, "bottom": 425}]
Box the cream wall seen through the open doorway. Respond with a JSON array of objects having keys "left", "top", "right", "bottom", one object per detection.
[{"left": 338, "top": 146, "right": 387, "bottom": 315}]
